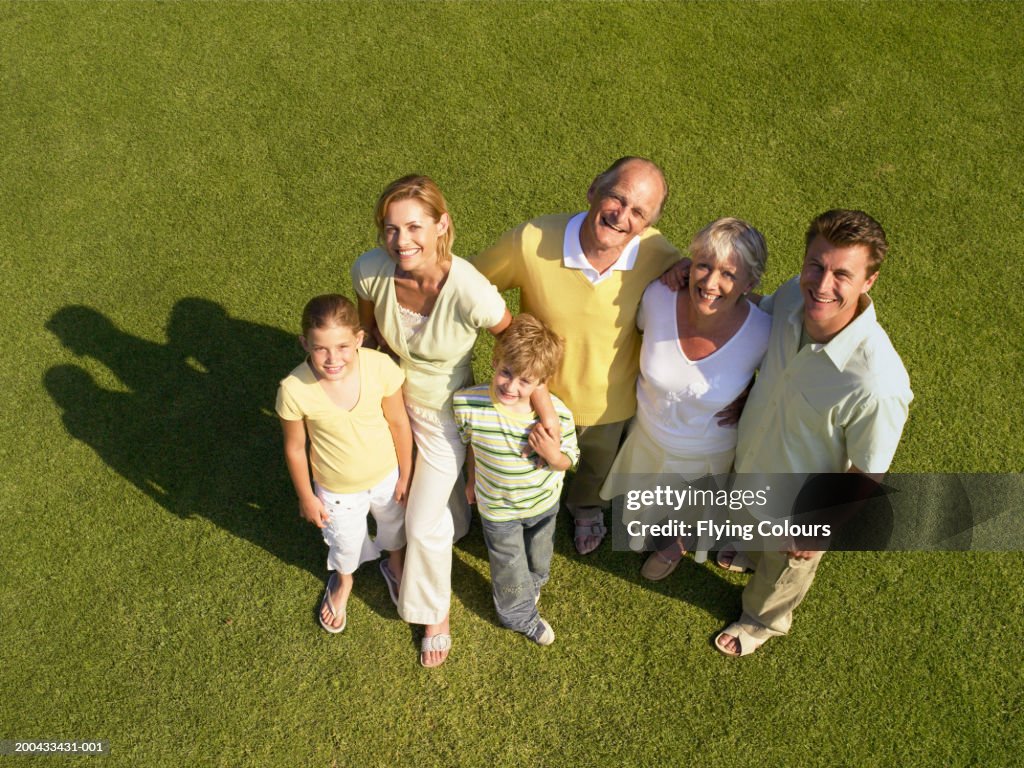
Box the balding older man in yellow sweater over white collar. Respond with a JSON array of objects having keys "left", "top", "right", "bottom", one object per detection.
[{"left": 473, "top": 157, "right": 679, "bottom": 554}]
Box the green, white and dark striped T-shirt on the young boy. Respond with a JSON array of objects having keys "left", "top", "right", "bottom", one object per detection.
[{"left": 452, "top": 384, "right": 580, "bottom": 521}]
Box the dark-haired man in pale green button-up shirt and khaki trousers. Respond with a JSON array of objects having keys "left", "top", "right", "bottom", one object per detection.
[{"left": 715, "top": 210, "right": 913, "bottom": 656}]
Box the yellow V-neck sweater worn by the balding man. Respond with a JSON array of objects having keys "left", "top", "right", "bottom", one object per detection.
[{"left": 473, "top": 214, "right": 679, "bottom": 426}]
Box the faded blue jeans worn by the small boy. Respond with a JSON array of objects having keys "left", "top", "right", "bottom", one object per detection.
[{"left": 481, "top": 504, "right": 558, "bottom": 634}]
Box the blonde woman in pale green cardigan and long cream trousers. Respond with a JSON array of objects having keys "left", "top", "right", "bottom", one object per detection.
[{"left": 352, "top": 176, "right": 554, "bottom": 667}]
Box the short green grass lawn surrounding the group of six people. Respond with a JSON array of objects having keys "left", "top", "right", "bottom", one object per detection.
[{"left": 0, "top": 2, "right": 1024, "bottom": 766}]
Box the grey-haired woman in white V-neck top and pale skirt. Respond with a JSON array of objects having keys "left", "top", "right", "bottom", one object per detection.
[{"left": 601, "top": 218, "right": 771, "bottom": 581}]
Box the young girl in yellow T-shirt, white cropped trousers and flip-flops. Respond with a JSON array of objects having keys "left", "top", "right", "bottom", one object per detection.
[{"left": 276, "top": 294, "right": 413, "bottom": 633}]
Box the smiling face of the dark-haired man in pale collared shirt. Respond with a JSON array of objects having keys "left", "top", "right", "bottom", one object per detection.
[{"left": 800, "top": 234, "right": 879, "bottom": 343}]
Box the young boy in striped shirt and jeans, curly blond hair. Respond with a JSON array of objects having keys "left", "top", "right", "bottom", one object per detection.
[{"left": 453, "top": 314, "right": 580, "bottom": 645}]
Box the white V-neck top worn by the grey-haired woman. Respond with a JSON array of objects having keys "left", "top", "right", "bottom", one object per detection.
[{"left": 637, "top": 281, "right": 771, "bottom": 455}]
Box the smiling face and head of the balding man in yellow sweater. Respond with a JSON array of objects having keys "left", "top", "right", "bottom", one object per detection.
[{"left": 580, "top": 161, "right": 665, "bottom": 255}]
